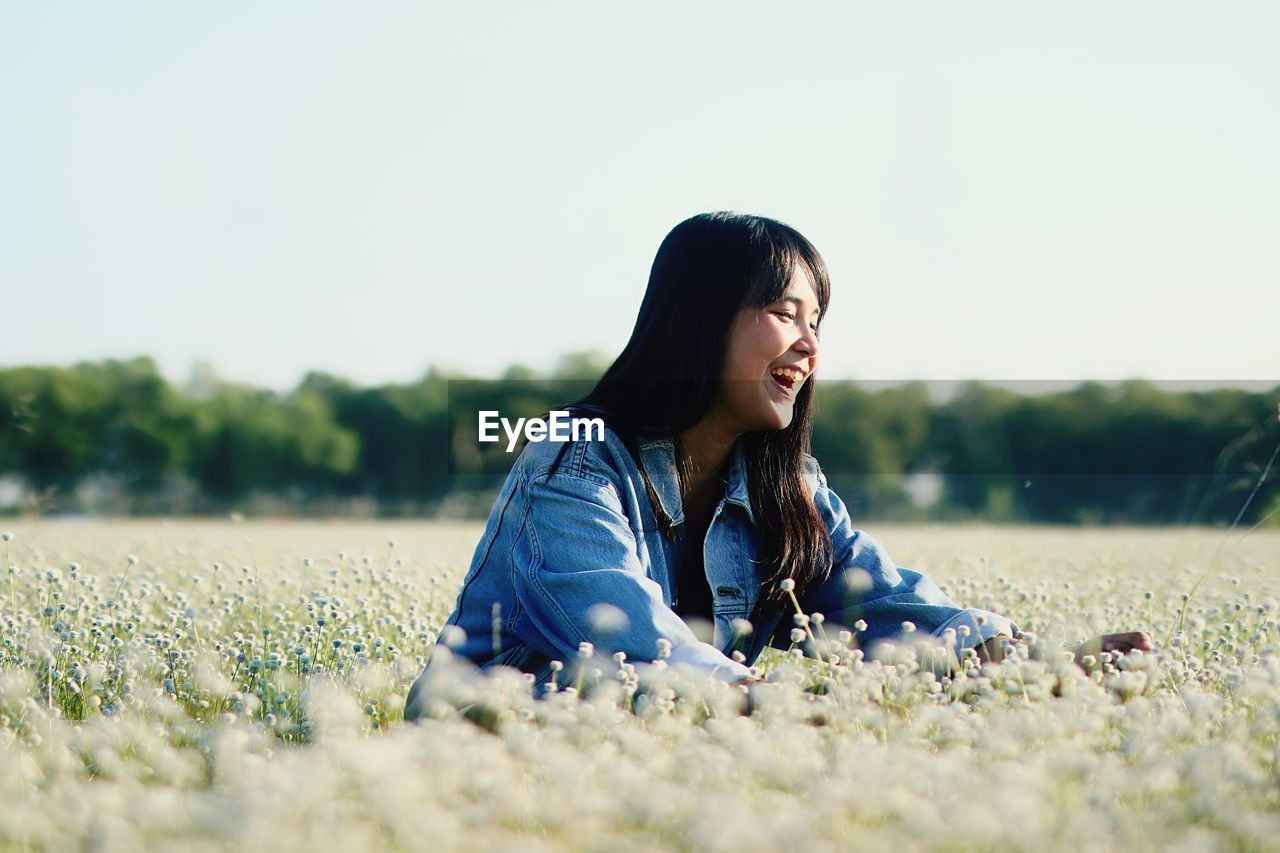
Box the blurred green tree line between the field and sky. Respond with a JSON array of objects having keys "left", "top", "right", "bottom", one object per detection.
[{"left": 0, "top": 353, "right": 1280, "bottom": 525}]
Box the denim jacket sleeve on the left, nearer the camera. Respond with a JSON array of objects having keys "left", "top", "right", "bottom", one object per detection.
[{"left": 512, "top": 470, "right": 750, "bottom": 680}]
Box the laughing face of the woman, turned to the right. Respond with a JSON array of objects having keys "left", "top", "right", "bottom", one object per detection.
[{"left": 713, "top": 264, "right": 819, "bottom": 433}]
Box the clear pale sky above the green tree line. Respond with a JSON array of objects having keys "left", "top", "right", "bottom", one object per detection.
[{"left": 0, "top": 1, "right": 1280, "bottom": 388}]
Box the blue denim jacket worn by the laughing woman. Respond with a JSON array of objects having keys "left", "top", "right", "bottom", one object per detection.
[{"left": 406, "top": 428, "right": 1020, "bottom": 719}]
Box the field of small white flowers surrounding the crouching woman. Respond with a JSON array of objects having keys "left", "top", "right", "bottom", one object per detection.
[{"left": 0, "top": 519, "right": 1280, "bottom": 850}]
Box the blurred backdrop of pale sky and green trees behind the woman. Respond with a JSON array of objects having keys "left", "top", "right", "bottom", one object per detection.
[{"left": 0, "top": 3, "right": 1280, "bottom": 525}]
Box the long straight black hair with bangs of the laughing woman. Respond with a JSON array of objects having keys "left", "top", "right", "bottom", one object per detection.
[{"left": 547, "top": 211, "right": 831, "bottom": 601}]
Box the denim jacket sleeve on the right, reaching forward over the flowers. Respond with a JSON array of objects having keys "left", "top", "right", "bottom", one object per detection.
[{"left": 774, "top": 457, "right": 1021, "bottom": 648}]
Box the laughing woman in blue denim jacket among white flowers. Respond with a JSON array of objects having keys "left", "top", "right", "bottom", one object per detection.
[{"left": 406, "top": 213, "right": 1151, "bottom": 720}]
